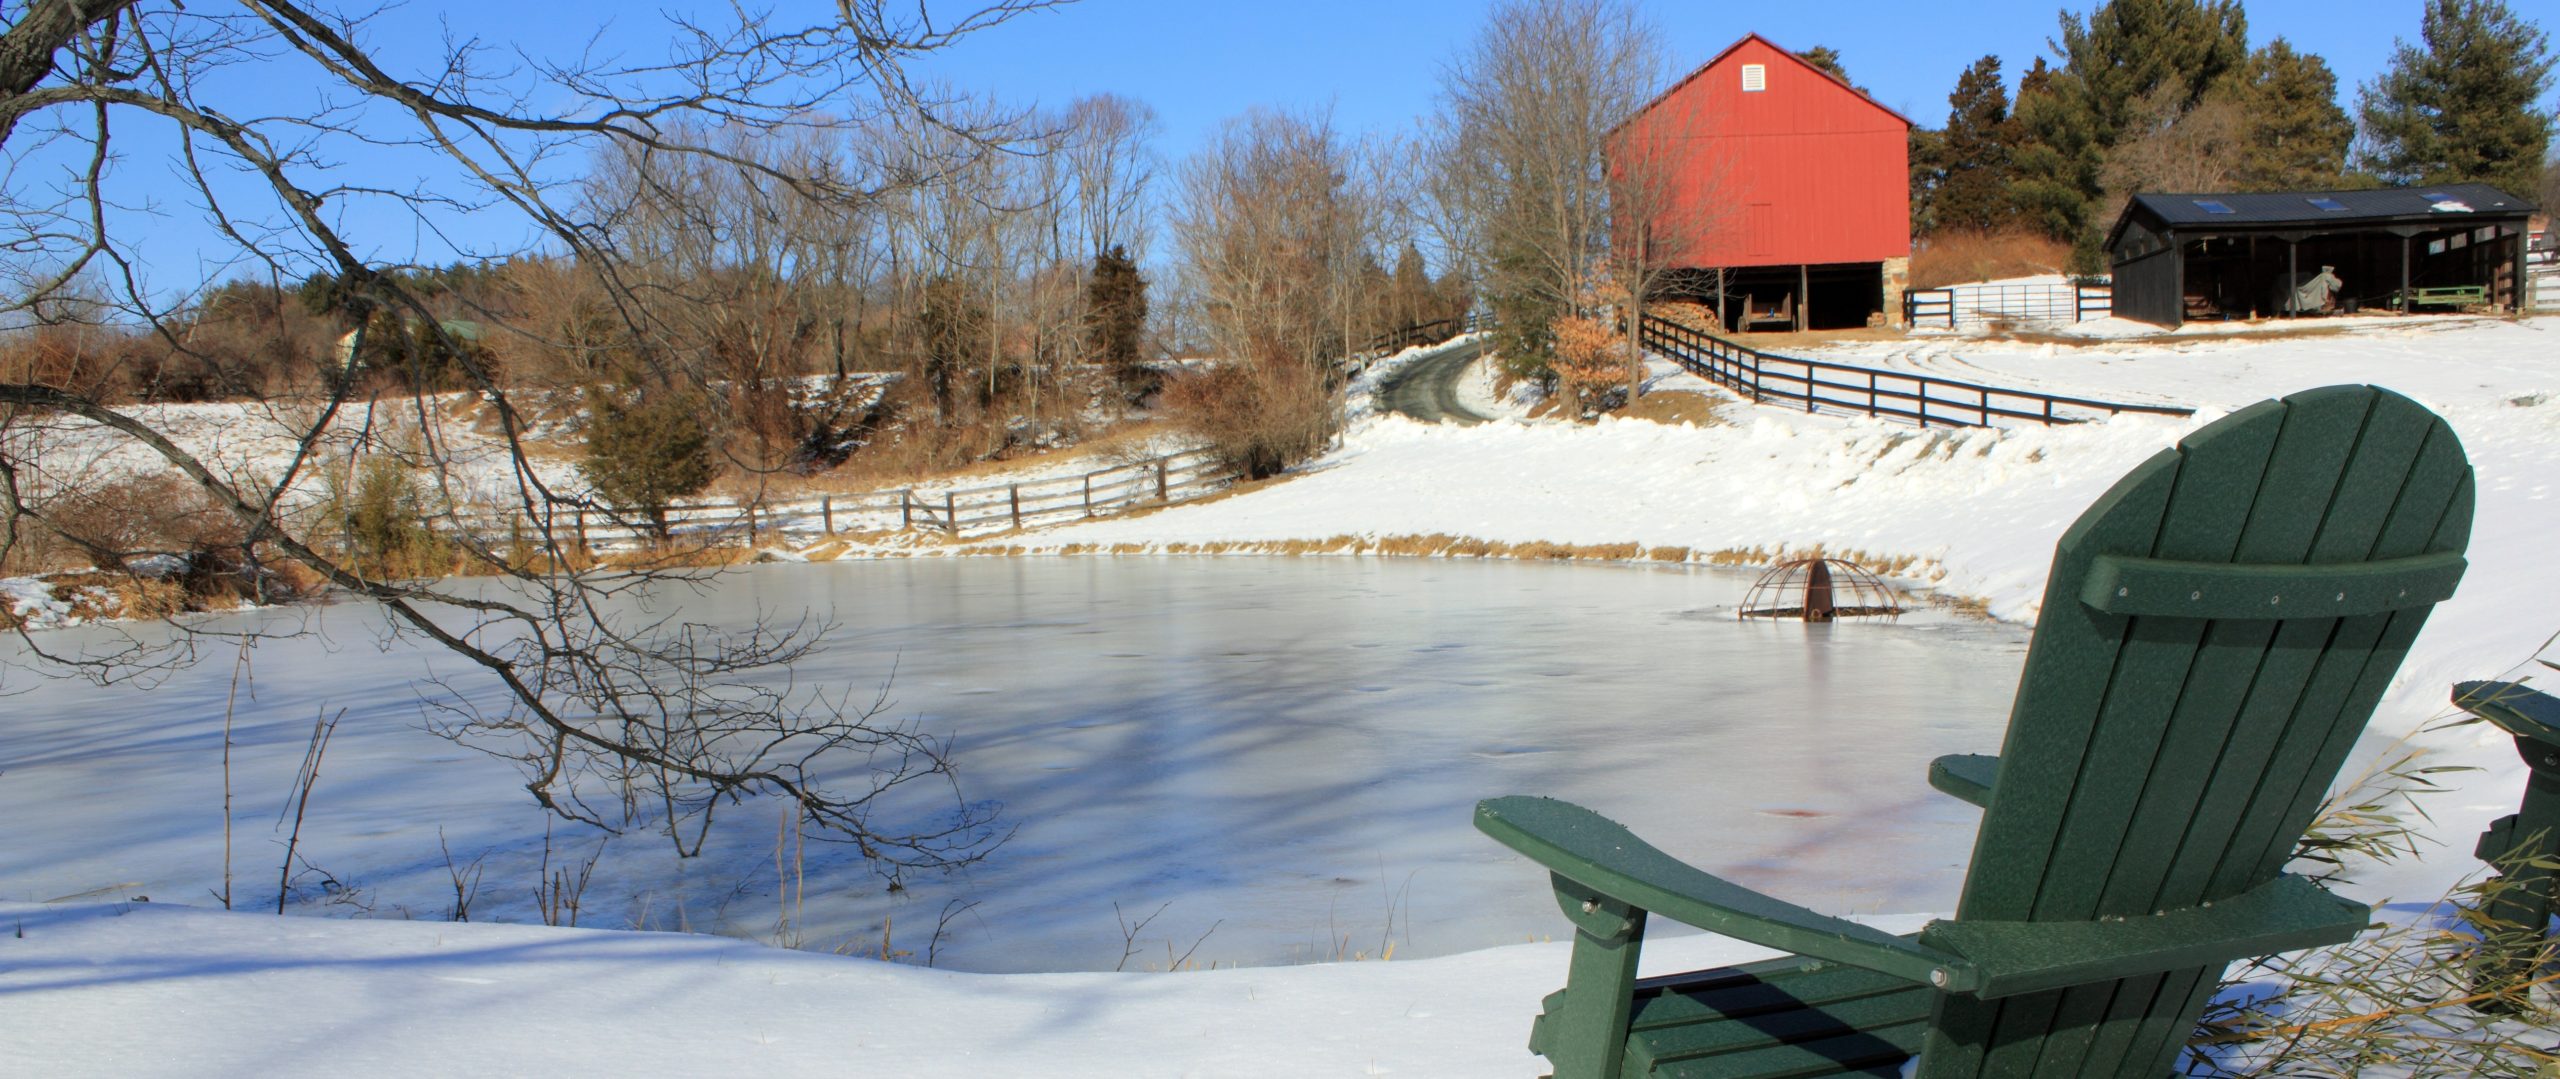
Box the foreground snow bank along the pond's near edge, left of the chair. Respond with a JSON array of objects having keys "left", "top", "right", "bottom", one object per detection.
[{"left": 0, "top": 902, "right": 1917, "bottom": 1079}]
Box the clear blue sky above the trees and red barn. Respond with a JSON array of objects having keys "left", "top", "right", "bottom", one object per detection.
[{"left": 55, "top": 0, "right": 2519, "bottom": 287}]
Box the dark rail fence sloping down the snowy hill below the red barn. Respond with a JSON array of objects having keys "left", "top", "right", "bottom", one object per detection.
[{"left": 1644, "top": 315, "right": 2194, "bottom": 428}]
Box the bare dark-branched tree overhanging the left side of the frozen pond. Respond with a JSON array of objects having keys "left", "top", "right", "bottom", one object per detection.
[{"left": 0, "top": 0, "right": 1047, "bottom": 871}]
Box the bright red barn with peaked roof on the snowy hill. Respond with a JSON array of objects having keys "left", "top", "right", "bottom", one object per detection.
[{"left": 1610, "top": 33, "right": 1912, "bottom": 328}]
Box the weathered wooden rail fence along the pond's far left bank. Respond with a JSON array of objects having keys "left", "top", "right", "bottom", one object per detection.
[{"left": 438, "top": 451, "right": 1234, "bottom": 548}]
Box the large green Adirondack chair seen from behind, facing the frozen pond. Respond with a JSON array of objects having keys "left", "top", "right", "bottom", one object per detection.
[{"left": 1475, "top": 387, "right": 2473, "bottom": 1079}]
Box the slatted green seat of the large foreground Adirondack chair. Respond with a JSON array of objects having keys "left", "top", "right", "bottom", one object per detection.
[{"left": 1528, "top": 956, "right": 1933, "bottom": 1076}]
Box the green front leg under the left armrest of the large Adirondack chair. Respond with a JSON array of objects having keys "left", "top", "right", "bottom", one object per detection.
[{"left": 1533, "top": 877, "right": 1646, "bottom": 1079}]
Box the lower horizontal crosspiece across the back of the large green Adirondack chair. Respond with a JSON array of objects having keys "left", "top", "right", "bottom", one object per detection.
[{"left": 1920, "top": 877, "right": 2373, "bottom": 1000}]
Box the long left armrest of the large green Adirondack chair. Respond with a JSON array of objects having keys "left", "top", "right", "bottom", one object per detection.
[{"left": 1475, "top": 795, "right": 1974, "bottom": 989}]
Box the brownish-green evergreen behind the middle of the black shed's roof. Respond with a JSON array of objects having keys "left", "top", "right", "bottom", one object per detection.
[{"left": 2232, "top": 38, "right": 2355, "bottom": 192}]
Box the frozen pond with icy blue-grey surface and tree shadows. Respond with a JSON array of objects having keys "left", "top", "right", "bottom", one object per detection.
[{"left": 0, "top": 559, "right": 2025, "bottom": 971}]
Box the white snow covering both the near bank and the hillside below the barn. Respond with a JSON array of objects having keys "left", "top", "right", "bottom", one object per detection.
[{"left": 0, "top": 318, "right": 2560, "bottom": 1076}]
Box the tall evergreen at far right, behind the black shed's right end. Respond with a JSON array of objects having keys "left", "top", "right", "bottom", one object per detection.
[{"left": 2355, "top": 0, "right": 2552, "bottom": 195}]
